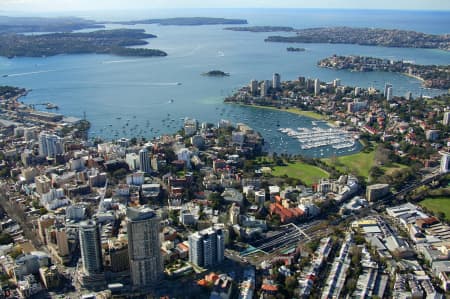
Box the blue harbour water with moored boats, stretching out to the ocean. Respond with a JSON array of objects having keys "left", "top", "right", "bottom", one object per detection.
[{"left": 0, "top": 10, "right": 450, "bottom": 156}]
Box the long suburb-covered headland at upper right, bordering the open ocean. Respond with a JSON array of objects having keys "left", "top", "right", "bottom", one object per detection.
[{"left": 265, "top": 27, "right": 450, "bottom": 51}]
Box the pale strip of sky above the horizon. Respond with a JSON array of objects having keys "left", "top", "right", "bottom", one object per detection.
[{"left": 0, "top": 0, "right": 450, "bottom": 12}]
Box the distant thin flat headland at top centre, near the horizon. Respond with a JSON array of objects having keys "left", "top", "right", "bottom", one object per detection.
[{"left": 112, "top": 17, "right": 247, "bottom": 26}]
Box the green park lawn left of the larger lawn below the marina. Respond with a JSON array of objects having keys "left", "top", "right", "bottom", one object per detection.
[{"left": 272, "top": 162, "right": 330, "bottom": 186}]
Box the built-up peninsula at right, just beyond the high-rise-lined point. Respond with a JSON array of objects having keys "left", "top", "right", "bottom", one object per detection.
[{"left": 317, "top": 55, "right": 450, "bottom": 89}]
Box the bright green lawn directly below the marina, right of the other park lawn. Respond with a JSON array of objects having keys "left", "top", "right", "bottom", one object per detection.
[{"left": 323, "top": 151, "right": 375, "bottom": 178}]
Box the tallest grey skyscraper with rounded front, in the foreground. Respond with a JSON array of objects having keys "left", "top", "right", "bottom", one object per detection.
[{"left": 127, "top": 208, "right": 163, "bottom": 288}]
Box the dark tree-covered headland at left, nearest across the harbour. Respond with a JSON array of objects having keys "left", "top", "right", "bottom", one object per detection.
[{"left": 0, "top": 29, "right": 167, "bottom": 58}]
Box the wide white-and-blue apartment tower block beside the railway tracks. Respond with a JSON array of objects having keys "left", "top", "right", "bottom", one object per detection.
[{"left": 189, "top": 227, "right": 225, "bottom": 267}]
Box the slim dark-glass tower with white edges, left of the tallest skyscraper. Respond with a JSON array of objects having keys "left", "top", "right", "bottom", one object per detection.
[{"left": 79, "top": 221, "right": 103, "bottom": 275}]
